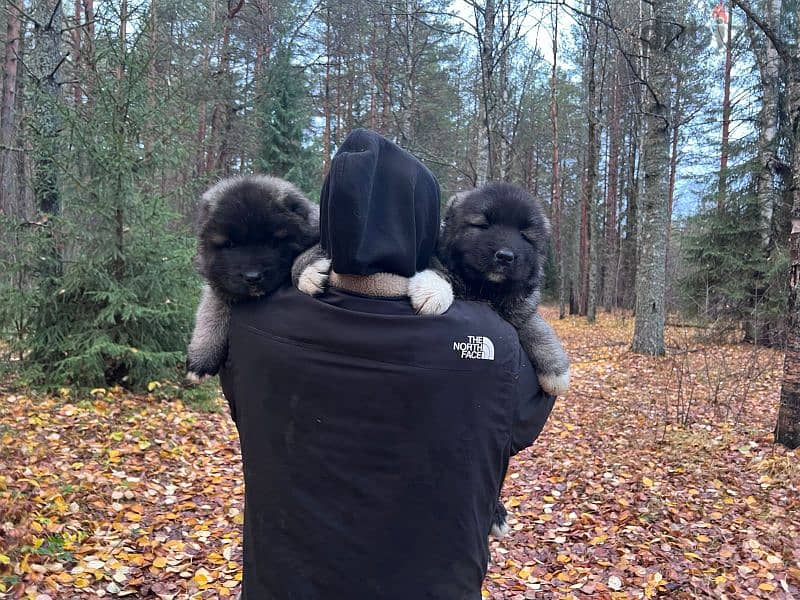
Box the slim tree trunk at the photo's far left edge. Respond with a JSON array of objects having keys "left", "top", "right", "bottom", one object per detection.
[{"left": 0, "top": 5, "right": 25, "bottom": 218}]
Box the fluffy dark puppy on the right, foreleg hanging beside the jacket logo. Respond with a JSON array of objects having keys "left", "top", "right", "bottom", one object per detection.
[{"left": 432, "top": 183, "right": 569, "bottom": 394}]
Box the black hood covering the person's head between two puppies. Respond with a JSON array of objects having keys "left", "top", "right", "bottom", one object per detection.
[{"left": 320, "top": 129, "right": 439, "bottom": 277}]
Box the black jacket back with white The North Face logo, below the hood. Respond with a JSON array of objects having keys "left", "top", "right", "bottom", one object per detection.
[{"left": 221, "top": 132, "right": 554, "bottom": 600}]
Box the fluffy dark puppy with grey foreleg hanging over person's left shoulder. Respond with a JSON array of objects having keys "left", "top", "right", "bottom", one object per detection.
[{"left": 187, "top": 175, "right": 319, "bottom": 380}]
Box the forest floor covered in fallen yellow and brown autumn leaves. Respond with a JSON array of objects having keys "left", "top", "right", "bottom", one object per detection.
[{"left": 0, "top": 309, "right": 800, "bottom": 600}]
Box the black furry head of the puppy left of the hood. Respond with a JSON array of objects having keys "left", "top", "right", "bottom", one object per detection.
[{"left": 196, "top": 176, "right": 319, "bottom": 298}]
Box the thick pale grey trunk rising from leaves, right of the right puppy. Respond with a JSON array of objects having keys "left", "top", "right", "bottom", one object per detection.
[{"left": 631, "top": 0, "right": 675, "bottom": 356}]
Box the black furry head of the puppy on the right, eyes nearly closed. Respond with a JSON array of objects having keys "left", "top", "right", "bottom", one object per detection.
[{"left": 439, "top": 183, "right": 550, "bottom": 300}]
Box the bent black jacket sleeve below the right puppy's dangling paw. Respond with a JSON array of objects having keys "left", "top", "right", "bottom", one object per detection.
[{"left": 511, "top": 349, "right": 556, "bottom": 456}]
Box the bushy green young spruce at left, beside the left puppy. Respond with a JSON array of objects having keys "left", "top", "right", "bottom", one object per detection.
[{"left": 0, "top": 7, "right": 199, "bottom": 389}]
